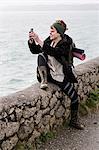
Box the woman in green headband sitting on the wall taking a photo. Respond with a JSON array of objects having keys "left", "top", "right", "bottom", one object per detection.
[{"left": 28, "top": 20, "right": 84, "bottom": 130}]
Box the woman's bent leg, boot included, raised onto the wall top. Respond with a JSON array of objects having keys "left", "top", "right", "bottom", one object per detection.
[{"left": 37, "top": 53, "right": 48, "bottom": 89}]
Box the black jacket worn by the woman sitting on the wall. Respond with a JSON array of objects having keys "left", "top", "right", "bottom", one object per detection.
[{"left": 28, "top": 34, "right": 77, "bottom": 83}]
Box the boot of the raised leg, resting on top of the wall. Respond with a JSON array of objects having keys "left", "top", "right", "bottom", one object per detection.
[{"left": 38, "top": 66, "right": 48, "bottom": 89}]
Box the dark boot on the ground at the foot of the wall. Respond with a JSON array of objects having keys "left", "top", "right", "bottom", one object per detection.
[{"left": 69, "top": 110, "right": 84, "bottom": 130}]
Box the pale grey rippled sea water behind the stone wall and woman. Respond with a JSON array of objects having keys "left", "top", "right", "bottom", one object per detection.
[{"left": 0, "top": 11, "right": 99, "bottom": 96}]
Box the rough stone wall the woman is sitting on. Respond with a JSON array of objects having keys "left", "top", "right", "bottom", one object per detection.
[{"left": 0, "top": 57, "right": 99, "bottom": 150}]
